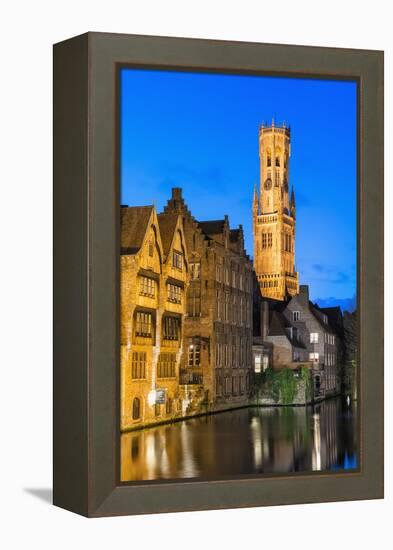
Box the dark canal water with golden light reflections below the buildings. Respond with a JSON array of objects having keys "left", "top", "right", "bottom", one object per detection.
[{"left": 121, "top": 398, "right": 358, "bottom": 481}]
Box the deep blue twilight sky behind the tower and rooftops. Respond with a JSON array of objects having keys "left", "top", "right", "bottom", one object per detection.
[{"left": 120, "top": 68, "right": 356, "bottom": 308}]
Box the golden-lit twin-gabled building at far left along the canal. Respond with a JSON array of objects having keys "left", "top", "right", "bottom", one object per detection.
[{"left": 121, "top": 206, "right": 188, "bottom": 429}]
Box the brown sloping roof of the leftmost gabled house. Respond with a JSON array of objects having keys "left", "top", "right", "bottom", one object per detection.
[{"left": 120, "top": 206, "right": 153, "bottom": 254}]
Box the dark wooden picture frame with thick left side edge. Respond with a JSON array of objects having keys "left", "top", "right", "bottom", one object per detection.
[{"left": 53, "top": 33, "right": 383, "bottom": 517}]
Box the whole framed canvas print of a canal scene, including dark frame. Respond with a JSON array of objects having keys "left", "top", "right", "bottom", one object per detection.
[{"left": 53, "top": 33, "right": 383, "bottom": 517}]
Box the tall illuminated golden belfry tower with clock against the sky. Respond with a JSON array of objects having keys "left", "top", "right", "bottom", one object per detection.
[{"left": 252, "top": 121, "right": 299, "bottom": 300}]
